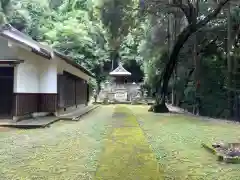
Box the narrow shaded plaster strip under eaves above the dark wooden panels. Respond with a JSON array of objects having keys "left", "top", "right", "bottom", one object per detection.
[{"left": 55, "top": 56, "right": 90, "bottom": 81}]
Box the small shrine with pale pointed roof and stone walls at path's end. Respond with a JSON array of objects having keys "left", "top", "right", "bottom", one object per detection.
[{"left": 98, "top": 63, "right": 143, "bottom": 103}]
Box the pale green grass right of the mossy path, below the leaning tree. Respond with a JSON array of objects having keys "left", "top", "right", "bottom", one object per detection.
[{"left": 131, "top": 106, "right": 240, "bottom": 180}]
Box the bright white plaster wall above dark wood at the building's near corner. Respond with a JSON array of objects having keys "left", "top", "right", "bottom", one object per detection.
[{"left": 14, "top": 48, "right": 57, "bottom": 93}]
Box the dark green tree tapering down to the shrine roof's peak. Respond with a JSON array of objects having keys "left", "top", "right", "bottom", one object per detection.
[{"left": 96, "top": 0, "right": 135, "bottom": 69}]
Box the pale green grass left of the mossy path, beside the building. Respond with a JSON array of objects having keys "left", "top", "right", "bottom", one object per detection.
[{"left": 0, "top": 107, "right": 113, "bottom": 180}]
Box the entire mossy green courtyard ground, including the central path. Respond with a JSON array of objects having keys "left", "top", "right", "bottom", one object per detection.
[{"left": 0, "top": 105, "right": 240, "bottom": 180}]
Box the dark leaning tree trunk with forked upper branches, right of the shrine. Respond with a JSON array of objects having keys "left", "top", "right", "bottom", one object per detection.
[{"left": 144, "top": 0, "right": 230, "bottom": 112}]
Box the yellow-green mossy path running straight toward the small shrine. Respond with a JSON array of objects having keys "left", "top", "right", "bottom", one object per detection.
[{"left": 95, "top": 106, "right": 162, "bottom": 180}]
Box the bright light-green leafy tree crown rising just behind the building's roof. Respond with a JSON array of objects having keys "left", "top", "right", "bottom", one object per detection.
[{"left": 47, "top": 9, "right": 109, "bottom": 84}]
